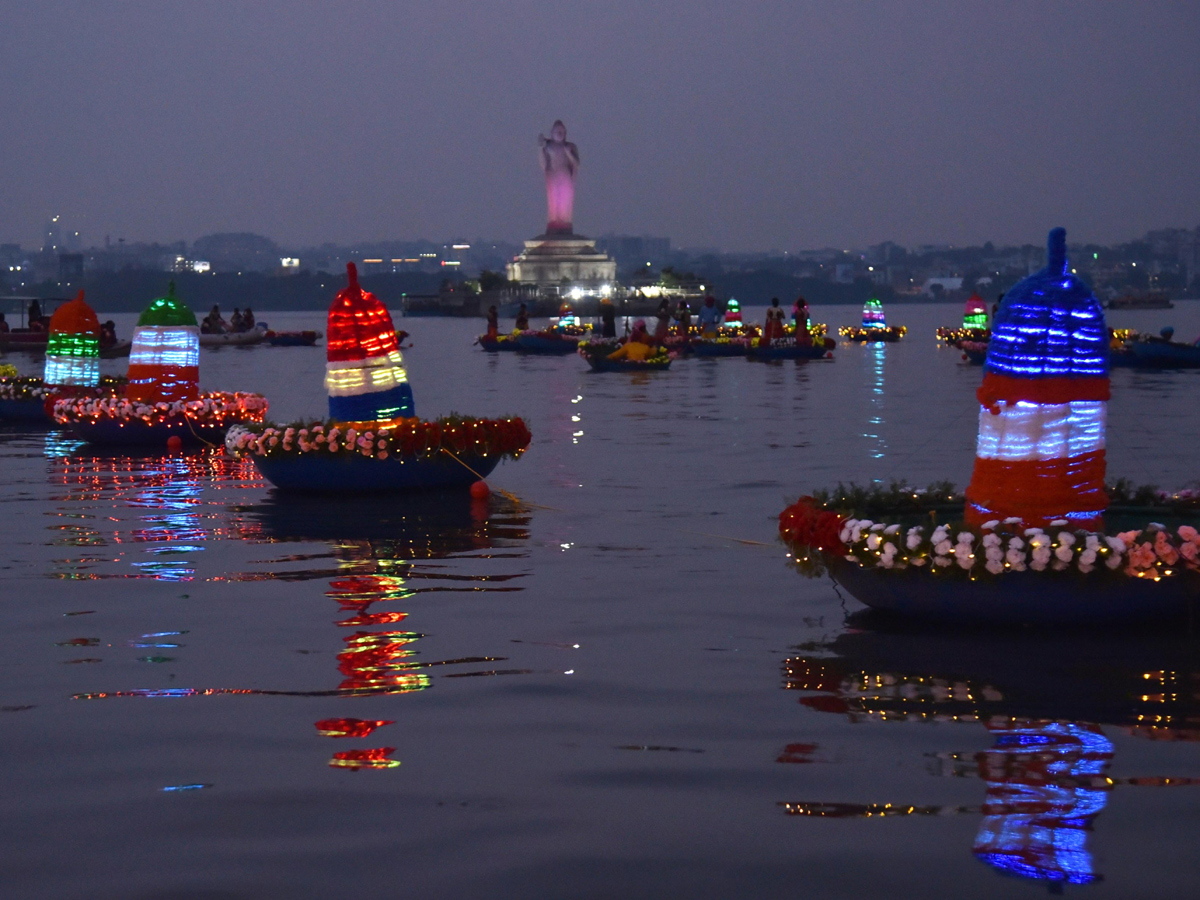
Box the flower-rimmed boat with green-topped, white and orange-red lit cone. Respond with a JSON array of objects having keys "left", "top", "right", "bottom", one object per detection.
[{"left": 53, "top": 282, "right": 266, "bottom": 446}]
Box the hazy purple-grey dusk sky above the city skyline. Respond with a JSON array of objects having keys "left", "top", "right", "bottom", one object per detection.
[{"left": 0, "top": 0, "right": 1200, "bottom": 250}]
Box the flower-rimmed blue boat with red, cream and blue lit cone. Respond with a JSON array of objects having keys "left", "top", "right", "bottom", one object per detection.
[{"left": 226, "top": 263, "right": 530, "bottom": 496}]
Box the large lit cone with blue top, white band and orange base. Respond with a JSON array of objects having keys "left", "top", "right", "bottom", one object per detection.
[{"left": 966, "top": 228, "right": 1109, "bottom": 526}]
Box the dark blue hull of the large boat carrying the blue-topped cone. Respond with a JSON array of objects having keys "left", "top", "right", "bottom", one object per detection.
[{"left": 830, "top": 559, "right": 1200, "bottom": 626}]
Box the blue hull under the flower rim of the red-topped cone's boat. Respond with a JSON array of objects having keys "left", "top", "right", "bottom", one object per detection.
[{"left": 250, "top": 454, "right": 499, "bottom": 493}]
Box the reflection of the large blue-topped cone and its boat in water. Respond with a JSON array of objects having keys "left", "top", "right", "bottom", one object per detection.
[{"left": 779, "top": 614, "right": 1200, "bottom": 884}]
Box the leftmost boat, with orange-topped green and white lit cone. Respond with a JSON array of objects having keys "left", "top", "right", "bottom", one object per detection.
[{"left": 0, "top": 290, "right": 125, "bottom": 424}]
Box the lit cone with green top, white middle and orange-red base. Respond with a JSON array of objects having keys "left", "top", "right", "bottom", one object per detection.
[{"left": 125, "top": 282, "right": 200, "bottom": 403}]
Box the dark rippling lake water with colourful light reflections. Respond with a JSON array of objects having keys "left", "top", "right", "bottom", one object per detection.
[{"left": 0, "top": 304, "right": 1200, "bottom": 899}]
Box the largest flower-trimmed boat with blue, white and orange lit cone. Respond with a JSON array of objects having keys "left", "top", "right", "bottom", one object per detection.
[{"left": 780, "top": 228, "right": 1200, "bottom": 625}]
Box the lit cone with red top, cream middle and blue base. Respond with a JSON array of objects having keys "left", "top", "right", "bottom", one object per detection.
[{"left": 325, "top": 263, "right": 415, "bottom": 422}]
